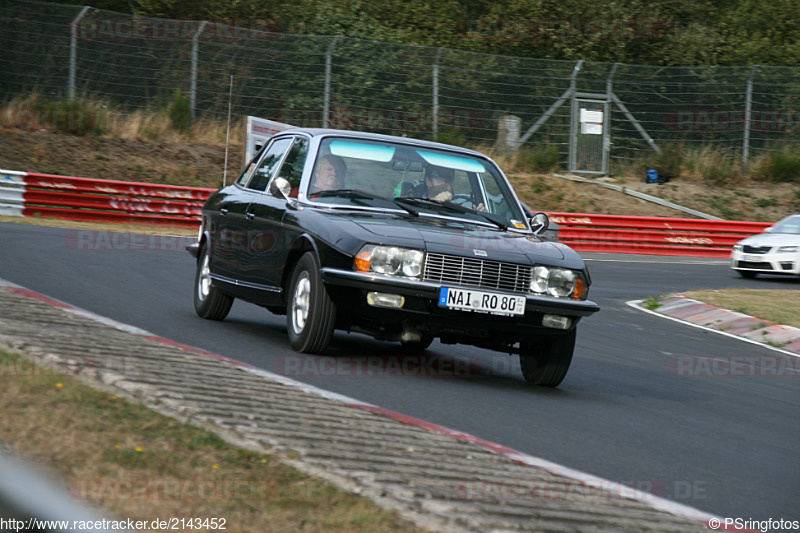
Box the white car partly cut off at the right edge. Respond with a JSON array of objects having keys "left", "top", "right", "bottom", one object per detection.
[{"left": 731, "top": 215, "right": 800, "bottom": 278}]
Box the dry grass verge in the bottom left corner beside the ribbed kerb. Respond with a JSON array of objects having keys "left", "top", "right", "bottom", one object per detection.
[{"left": 0, "top": 350, "right": 422, "bottom": 532}]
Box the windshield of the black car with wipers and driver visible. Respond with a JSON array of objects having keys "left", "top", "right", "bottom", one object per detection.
[{"left": 307, "top": 137, "right": 528, "bottom": 229}]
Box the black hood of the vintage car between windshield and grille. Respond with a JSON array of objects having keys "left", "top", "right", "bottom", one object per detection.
[{"left": 340, "top": 210, "right": 574, "bottom": 264}]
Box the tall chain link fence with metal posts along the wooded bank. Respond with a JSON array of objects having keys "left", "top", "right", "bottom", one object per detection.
[{"left": 0, "top": 0, "right": 800, "bottom": 171}]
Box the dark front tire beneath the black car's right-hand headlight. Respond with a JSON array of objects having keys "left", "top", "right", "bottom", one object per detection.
[{"left": 519, "top": 328, "right": 577, "bottom": 387}]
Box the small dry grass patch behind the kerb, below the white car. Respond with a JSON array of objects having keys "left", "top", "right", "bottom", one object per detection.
[{"left": 683, "top": 289, "right": 800, "bottom": 328}]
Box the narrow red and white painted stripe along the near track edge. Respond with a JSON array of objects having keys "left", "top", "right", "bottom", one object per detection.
[{"left": 0, "top": 278, "right": 724, "bottom": 532}]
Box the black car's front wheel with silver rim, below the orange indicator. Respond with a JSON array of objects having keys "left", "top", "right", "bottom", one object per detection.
[{"left": 286, "top": 252, "right": 336, "bottom": 354}]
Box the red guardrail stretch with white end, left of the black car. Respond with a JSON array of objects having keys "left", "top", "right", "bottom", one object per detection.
[{"left": 0, "top": 170, "right": 214, "bottom": 228}]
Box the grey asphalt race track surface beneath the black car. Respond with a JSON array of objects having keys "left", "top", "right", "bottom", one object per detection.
[{"left": 0, "top": 223, "right": 800, "bottom": 520}]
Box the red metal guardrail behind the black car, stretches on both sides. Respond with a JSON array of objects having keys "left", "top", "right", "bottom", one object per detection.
[{"left": 0, "top": 170, "right": 770, "bottom": 257}]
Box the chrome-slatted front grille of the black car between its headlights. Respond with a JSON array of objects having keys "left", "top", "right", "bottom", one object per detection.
[{"left": 423, "top": 253, "right": 533, "bottom": 292}]
